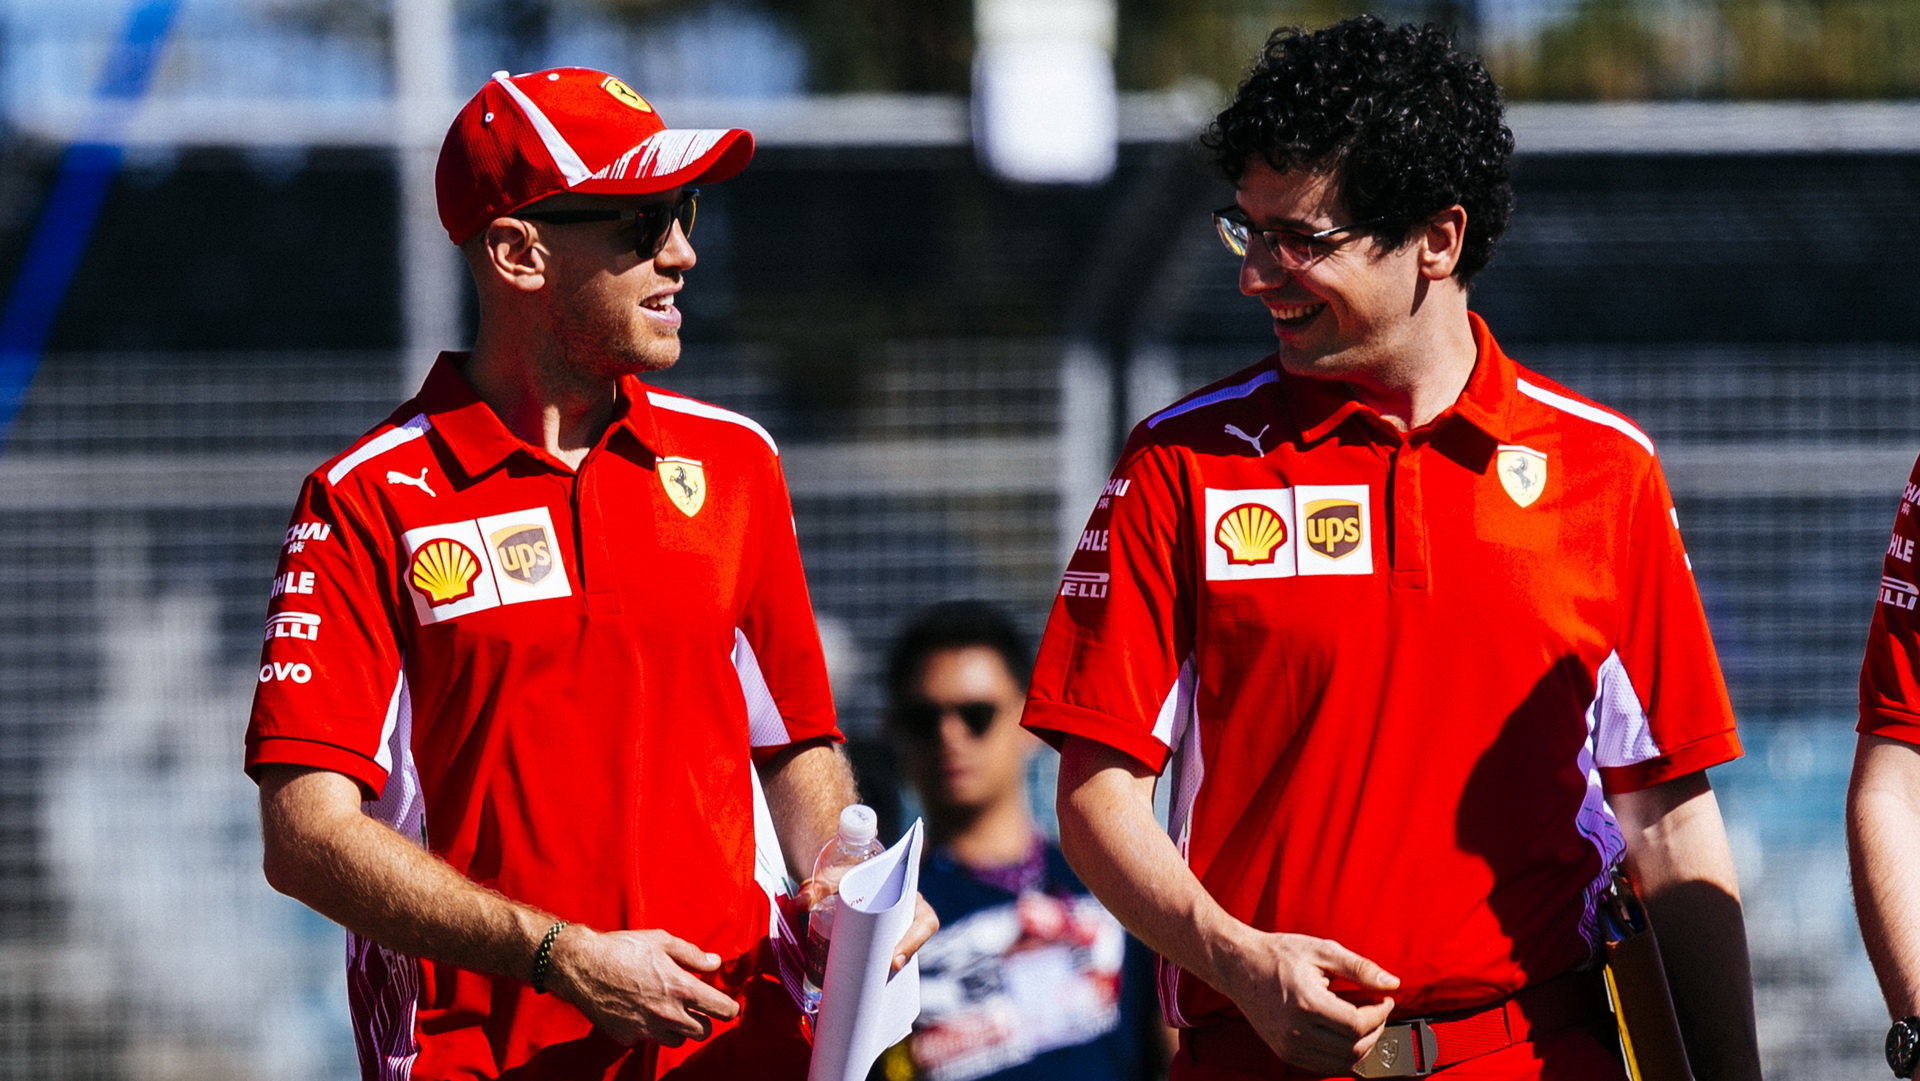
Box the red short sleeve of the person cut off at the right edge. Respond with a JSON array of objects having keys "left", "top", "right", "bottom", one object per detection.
[{"left": 1859, "top": 451, "right": 1920, "bottom": 743}]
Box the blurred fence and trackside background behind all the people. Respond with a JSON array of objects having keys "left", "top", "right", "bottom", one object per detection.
[{"left": 0, "top": 0, "right": 1920, "bottom": 1081}]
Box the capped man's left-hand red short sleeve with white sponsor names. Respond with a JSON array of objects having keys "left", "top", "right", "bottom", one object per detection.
[{"left": 246, "top": 476, "right": 407, "bottom": 799}]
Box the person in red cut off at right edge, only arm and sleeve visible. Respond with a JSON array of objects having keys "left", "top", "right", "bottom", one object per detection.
[{"left": 1847, "top": 463, "right": 1920, "bottom": 1077}]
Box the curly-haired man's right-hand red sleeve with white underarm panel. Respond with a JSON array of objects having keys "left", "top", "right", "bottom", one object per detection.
[{"left": 1590, "top": 459, "right": 1740, "bottom": 793}]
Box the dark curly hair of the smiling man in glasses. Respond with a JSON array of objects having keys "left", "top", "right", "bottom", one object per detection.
[{"left": 1200, "top": 15, "right": 1513, "bottom": 282}]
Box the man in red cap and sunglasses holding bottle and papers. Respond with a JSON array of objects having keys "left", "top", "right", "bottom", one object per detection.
[{"left": 246, "top": 69, "right": 933, "bottom": 1081}]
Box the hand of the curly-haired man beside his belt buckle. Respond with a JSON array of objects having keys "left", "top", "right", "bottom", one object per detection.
[{"left": 1221, "top": 931, "right": 1400, "bottom": 1075}]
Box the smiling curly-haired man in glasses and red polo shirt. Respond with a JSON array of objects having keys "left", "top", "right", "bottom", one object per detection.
[{"left": 1025, "top": 17, "right": 1759, "bottom": 1081}]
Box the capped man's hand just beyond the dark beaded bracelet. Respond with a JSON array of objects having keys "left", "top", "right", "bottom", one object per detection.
[{"left": 547, "top": 924, "right": 739, "bottom": 1046}]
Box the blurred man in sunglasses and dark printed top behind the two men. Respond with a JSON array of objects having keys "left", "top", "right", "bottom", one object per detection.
[{"left": 879, "top": 601, "right": 1165, "bottom": 1081}]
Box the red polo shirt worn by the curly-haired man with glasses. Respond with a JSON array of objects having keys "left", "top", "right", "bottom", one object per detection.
[{"left": 1025, "top": 317, "right": 1740, "bottom": 1025}]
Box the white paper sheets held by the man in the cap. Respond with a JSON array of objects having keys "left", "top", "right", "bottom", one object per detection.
[{"left": 806, "top": 820, "right": 925, "bottom": 1081}]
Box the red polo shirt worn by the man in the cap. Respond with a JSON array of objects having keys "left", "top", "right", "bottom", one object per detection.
[{"left": 246, "top": 353, "right": 839, "bottom": 1079}]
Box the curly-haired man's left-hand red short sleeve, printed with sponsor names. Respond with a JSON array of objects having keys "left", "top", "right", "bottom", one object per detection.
[{"left": 1021, "top": 430, "right": 1192, "bottom": 770}]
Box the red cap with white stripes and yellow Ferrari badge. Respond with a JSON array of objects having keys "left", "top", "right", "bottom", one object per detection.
[{"left": 434, "top": 67, "right": 753, "bottom": 244}]
